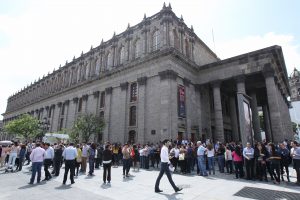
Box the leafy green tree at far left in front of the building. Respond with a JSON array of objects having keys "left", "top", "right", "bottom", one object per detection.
[{"left": 4, "top": 114, "right": 41, "bottom": 140}]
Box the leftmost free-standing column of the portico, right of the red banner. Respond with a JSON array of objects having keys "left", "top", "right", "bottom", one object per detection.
[{"left": 212, "top": 81, "right": 224, "bottom": 142}]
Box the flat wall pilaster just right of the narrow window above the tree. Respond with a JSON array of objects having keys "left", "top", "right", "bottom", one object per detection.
[{"left": 103, "top": 87, "right": 113, "bottom": 142}]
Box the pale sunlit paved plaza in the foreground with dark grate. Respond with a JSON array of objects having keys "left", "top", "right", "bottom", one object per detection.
[{"left": 0, "top": 164, "right": 300, "bottom": 200}]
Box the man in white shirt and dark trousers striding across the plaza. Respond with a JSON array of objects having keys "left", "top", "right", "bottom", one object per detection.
[{"left": 154, "top": 139, "right": 182, "bottom": 192}]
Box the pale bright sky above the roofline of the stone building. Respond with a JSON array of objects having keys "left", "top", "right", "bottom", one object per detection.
[{"left": 0, "top": 0, "right": 300, "bottom": 120}]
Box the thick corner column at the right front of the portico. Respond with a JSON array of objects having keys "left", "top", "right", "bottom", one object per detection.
[{"left": 263, "top": 64, "right": 284, "bottom": 143}]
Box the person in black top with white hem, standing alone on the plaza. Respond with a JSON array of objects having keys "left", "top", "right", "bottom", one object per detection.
[{"left": 102, "top": 144, "right": 112, "bottom": 184}]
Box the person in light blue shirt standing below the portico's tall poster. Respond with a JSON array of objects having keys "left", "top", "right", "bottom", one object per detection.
[{"left": 243, "top": 142, "right": 254, "bottom": 180}]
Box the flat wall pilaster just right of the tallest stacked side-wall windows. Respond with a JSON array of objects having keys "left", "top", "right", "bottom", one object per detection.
[{"left": 137, "top": 76, "right": 147, "bottom": 144}]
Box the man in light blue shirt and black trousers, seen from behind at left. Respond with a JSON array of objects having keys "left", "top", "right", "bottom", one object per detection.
[{"left": 63, "top": 143, "right": 77, "bottom": 185}]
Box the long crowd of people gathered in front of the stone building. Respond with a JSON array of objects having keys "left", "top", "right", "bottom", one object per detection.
[{"left": 0, "top": 140, "right": 300, "bottom": 188}]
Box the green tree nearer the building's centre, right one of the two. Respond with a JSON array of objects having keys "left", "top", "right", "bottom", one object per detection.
[{"left": 69, "top": 113, "right": 105, "bottom": 142}]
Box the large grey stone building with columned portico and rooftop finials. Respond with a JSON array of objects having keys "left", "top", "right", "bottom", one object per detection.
[{"left": 3, "top": 5, "right": 292, "bottom": 143}]
